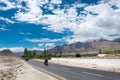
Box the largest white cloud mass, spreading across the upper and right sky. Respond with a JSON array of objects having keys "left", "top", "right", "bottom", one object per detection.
[{"left": 0, "top": 0, "right": 120, "bottom": 43}]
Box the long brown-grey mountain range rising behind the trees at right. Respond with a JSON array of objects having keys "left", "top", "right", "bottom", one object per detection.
[{"left": 48, "top": 39, "right": 120, "bottom": 54}]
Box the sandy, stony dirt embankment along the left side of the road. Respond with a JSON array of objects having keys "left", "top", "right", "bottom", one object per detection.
[{"left": 0, "top": 56, "right": 57, "bottom": 80}]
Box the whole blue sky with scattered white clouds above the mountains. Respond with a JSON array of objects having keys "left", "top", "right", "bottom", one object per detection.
[{"left": 0, "top": 0, "right": 120, "bottom": 52}]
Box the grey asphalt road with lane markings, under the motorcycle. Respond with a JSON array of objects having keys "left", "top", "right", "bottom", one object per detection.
[{"left": 28, "top": 60, "right": 120, "bottom": 80}]
